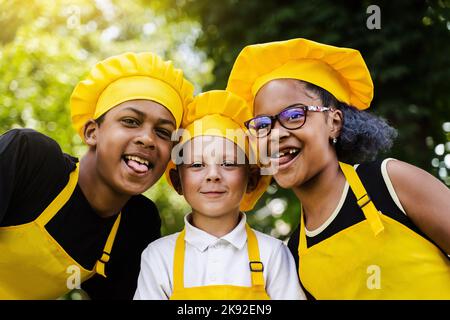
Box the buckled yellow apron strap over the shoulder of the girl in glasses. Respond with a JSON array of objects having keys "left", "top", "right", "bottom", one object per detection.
[{"left": 339, "top": 162, "right": 384, "bottom": 235}]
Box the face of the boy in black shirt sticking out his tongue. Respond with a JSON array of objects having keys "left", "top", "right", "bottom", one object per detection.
[{"left": 86, "top": 100, "right": 176, "bottom": 195}]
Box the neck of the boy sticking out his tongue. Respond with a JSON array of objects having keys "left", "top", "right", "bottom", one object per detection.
[{"left": 78, "top": 151, "right": 130, "bottom": 218}]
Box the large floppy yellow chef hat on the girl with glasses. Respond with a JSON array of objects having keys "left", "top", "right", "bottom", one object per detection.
[{"left": 227, "top": 38, "right": 373, "bottom": 110}]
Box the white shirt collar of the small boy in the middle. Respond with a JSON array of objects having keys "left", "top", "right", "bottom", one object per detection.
[{"left": 184, "top": 213, "right": 247, "bottom": 252}]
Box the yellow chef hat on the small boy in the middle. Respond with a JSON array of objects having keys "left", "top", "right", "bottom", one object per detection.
[{"left": 165, "top": 90, "right": 271, "bottom": 211}]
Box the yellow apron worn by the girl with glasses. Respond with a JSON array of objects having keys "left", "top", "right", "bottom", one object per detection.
[{"left": 298, "top": 163, "right": 450, "bottom": 299}]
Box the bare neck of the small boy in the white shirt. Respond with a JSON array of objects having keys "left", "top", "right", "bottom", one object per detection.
[{"left": 191, "top": 209, "right": 240, "bottom": 238}]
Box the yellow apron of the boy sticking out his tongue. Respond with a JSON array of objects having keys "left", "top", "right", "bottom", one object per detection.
[{"left": 0, "top": 165, "right": 120, "bottom": 299}]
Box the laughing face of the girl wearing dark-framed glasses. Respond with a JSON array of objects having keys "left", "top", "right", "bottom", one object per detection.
[{"left": 254, "top": 79, "right": 340, "bottom": 188}]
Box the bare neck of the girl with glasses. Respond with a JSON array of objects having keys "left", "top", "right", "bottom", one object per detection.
[{"left": 293, "top": 161, "right": 346, "bottom": 230}]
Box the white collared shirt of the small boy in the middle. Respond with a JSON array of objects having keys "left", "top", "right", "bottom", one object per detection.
[{"left": 134, "top": 214, "right": 306, "bottom": 300}]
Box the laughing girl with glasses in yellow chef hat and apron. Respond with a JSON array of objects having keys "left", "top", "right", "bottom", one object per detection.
[{"left": 227, "top": 39, "right": 450, "bottom": 299}]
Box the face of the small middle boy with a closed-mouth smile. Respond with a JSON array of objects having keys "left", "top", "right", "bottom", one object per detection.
[{"left": 178, "top": 136, "right": 249, "bottom": 218}]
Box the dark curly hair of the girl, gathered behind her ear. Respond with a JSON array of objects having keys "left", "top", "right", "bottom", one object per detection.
[{"left": 301, "top": 81, "right": 397, "bottom": 164}]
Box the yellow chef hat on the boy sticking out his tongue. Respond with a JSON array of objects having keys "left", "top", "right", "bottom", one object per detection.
[{"left": 70, "top": 52, "right": 194, "bottom": 140}]
